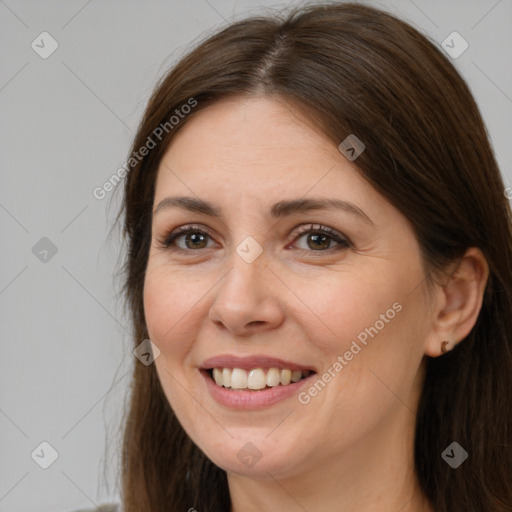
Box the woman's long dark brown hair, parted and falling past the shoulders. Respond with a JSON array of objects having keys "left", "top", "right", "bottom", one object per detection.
[{"left": 118, "top": 3, "right": 512, "bottom": 512}]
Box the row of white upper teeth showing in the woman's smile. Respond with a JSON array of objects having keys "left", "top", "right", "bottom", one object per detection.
[{"left": 213, "top": 368, "right": 311, "bottom": 390}]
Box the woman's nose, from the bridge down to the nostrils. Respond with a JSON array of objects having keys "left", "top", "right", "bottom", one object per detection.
[{"left": 209, "top": 247, "right": 284, "bottom": 337}]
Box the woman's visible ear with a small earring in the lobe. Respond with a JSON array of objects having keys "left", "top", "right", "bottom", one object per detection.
[{"left": 425, "top": 247, "right": 489, "bottom": 357}]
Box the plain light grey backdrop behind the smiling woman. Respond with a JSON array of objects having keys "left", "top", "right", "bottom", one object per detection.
[{"left": 0, "top": 0, "right": 512, "bottom": 512}]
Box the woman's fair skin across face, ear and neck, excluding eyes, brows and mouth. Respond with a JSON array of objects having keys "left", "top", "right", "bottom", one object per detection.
[{"left": 144, "top": 97, "right": 488, "bottom": 512}]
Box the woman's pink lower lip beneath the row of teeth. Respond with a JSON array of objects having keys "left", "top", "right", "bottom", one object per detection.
[{"left": 201, "top": 370, "right": 316, "bottom": 411}]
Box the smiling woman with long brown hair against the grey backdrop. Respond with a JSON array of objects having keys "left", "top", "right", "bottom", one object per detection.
[{"left": 98, "top": 4, "right": 512, "bottom": 512}]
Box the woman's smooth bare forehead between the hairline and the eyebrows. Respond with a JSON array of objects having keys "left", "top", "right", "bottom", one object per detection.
[{"left": 157, "top": 97, "right": 369, "bottom": 201}]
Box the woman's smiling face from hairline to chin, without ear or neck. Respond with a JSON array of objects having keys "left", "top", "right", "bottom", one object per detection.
[{"left": 144, "top": 98, "right": 432, "bottom": 478}]
